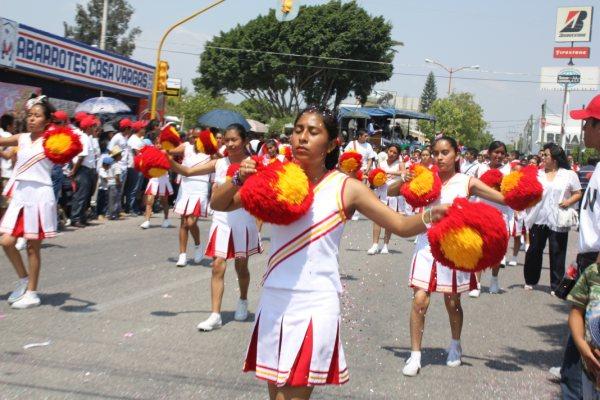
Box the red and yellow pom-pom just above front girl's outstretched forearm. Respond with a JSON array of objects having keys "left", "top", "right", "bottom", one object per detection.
[{"left": 400, "top": 164, "right": 442, "bottom": 208}]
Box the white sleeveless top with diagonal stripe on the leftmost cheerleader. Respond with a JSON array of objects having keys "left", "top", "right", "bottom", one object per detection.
[{"left": 13, "top": 133, "right": 53, "bottom": 186}]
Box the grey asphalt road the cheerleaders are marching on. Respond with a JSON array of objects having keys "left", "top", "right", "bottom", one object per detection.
[{"left": 0, "top": 214, "right": 576, "bottom": 400}]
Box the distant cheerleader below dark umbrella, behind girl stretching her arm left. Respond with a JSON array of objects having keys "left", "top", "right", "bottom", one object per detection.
[{"left": 169, "top": 130, "right": 211, "bottom": 267}]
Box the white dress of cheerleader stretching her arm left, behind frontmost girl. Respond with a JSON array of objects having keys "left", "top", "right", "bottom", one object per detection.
[{"left": 205, "top": 157, "right": 262, "bottom": 260}]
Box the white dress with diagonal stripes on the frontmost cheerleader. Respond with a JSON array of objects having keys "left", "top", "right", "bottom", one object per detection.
[{"left": 244, "top": 171, "right": 348, "bottom": 386}]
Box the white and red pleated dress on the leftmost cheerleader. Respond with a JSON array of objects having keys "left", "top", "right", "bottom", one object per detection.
[{"left": 0, "top": 133, "right": 56, "bottom": 240}]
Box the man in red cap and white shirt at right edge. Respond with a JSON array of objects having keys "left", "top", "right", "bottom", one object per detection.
[{"left": 560, "top": 95, "right": 600, "bottom": 399}]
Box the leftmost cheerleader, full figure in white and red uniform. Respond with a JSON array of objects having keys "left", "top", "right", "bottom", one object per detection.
[{"left": 0, "top": 96, "right": 56, "bottom": 309}]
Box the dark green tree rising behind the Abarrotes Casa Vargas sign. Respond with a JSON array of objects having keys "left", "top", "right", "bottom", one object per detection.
[{"left": 63, "top": 0, "right": 142, "bottom": 57}]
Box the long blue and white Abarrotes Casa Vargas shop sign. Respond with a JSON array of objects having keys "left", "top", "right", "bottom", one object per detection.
[{"left": 0, "top": 18, "right": 154, "bottom": 97}]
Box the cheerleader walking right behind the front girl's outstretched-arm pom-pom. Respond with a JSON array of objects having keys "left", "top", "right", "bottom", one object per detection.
[{"left": 402, "top": 136, "right": 504, "bottom": 376}]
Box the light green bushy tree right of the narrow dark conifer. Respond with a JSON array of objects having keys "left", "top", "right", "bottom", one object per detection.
[{"left": 421, "top": 93, "right": 494, "bottom": 149}]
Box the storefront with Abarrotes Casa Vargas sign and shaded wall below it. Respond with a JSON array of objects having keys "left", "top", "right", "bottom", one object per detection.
[{"left": 0, "top": 18, "right": 154, "bottom": 119}]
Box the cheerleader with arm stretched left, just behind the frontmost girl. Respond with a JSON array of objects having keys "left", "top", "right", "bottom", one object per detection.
[{"left": 169, "top": 124, "right": 262, "bottom": 332}]
